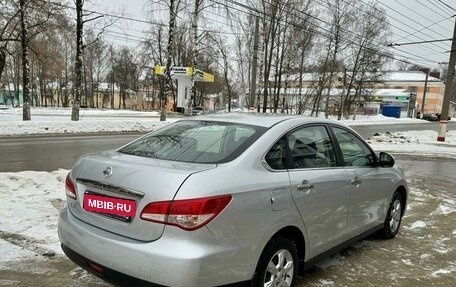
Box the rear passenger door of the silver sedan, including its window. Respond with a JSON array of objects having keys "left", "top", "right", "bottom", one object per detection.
[{"left": 287, "top": 125, "right": 351, "bottom": 257}]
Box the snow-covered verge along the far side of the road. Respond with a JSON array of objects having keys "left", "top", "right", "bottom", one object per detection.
[{"left": 0, "top": 108, "right": 430, "bottom": 136}]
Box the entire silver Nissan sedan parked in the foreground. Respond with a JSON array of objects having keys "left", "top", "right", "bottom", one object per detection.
[{"left": 58, "top": 114, "right": 408, "bottom": 287}]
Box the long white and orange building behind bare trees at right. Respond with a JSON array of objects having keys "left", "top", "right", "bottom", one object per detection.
[{"left": 257, "top": 71, "right": 445, "bottom": 117}]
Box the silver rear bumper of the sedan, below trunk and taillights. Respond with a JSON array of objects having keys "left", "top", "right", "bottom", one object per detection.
[{"left": 58, "top": 208, "right": 251, "bottom": 287}]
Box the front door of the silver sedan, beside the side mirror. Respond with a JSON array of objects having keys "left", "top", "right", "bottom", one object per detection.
[{"left": 332, "top": 126, "right": 391, "bottom": 237}]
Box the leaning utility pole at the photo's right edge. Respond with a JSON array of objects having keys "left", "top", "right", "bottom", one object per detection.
[{"left": 437, "top": 17, "right": 456, "bottom": 142}]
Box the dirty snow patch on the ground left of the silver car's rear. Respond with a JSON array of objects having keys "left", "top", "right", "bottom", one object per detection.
[{"left": 0, "top": 169, "right": 68, "bottom": 264}]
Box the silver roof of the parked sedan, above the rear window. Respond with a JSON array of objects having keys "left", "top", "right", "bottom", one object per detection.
[{"left": 185, "top": 112, "right": 334, "bottom": 128}]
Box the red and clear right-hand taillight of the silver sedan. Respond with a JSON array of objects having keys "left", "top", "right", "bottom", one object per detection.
[{"left": 141, "top": 195, "right": 231, "bottom": 230}]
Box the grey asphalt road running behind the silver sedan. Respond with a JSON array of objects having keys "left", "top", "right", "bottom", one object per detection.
[{"left": 0, "top": 122, "right": 456, "bottom": 172}]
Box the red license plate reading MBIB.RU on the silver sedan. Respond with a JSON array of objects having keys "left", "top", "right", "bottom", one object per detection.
[{"left": 83, "top": 193, "right": 136, "bottom": 218}]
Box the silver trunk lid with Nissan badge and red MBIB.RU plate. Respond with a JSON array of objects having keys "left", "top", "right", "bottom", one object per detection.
[{"left": 68, "top": 151, "right": 216, "bottom": 241}]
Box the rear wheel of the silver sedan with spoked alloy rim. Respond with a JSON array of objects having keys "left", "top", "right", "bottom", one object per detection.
[{"left": 252, "top": 237, "right": 298, "bottom": 287}]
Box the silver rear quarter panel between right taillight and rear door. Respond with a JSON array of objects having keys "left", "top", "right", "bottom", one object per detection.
[{"left": 176, "top": 124, "right": 307, "bottom": 278}]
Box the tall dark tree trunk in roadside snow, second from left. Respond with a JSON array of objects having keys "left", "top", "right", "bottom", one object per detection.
[{"left": 71, "top": 0, "right": 83, "bottom": 121}]
